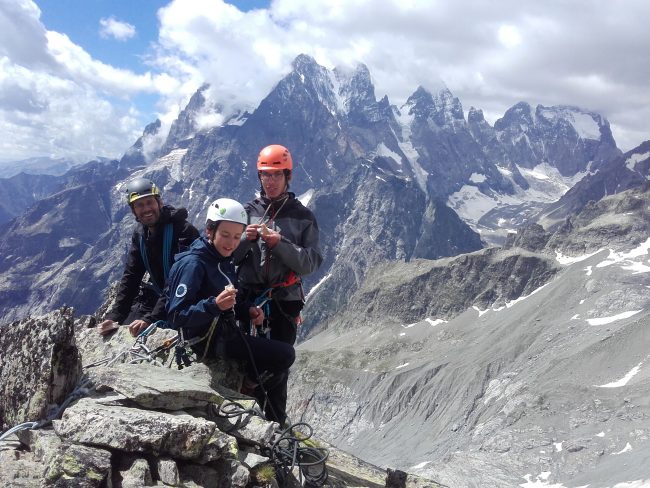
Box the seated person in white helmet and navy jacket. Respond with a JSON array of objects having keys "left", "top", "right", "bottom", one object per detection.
[{"left": 166, "top": 198, "right": 295, "bottom": 412}]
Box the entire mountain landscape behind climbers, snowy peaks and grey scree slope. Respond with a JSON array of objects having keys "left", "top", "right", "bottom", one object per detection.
[{"left": 0, "top": 51, "right": 650, "bottom": 487}]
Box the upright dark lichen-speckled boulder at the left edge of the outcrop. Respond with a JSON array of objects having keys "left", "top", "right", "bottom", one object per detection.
[{"left": 0, "top": 308, "right": 81, "bottom": 431}]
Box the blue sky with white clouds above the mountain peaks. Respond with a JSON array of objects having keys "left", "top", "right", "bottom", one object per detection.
[{"left": 0, "top": 0, "right": 650, "bottom": 161}]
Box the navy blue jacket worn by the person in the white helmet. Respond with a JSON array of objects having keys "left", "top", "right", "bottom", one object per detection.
[{"left": 166, "top": 237, "right": 250, "bottom": 339}]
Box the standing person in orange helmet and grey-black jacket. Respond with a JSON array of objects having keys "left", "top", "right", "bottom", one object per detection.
[{"left": 234, "top": 144, "right": 323, "bottom": 424}]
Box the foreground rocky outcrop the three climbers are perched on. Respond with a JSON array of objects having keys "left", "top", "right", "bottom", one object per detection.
[{"left": 0, "top": 309, "right": 440, "bottom": 488}]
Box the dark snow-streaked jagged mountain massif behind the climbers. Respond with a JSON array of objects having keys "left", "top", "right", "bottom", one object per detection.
[{"left": 0, "top": 55, "right": 618, "bottom": 329}]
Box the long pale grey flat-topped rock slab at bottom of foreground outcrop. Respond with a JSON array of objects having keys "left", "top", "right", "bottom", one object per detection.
[{"left": 54, "top": 398, "right": 215, "bottom": 459}]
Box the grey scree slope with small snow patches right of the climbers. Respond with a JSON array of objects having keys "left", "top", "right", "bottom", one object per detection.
[{"left": 289, "top": 185, "right": 650, "bottom": 488}]
